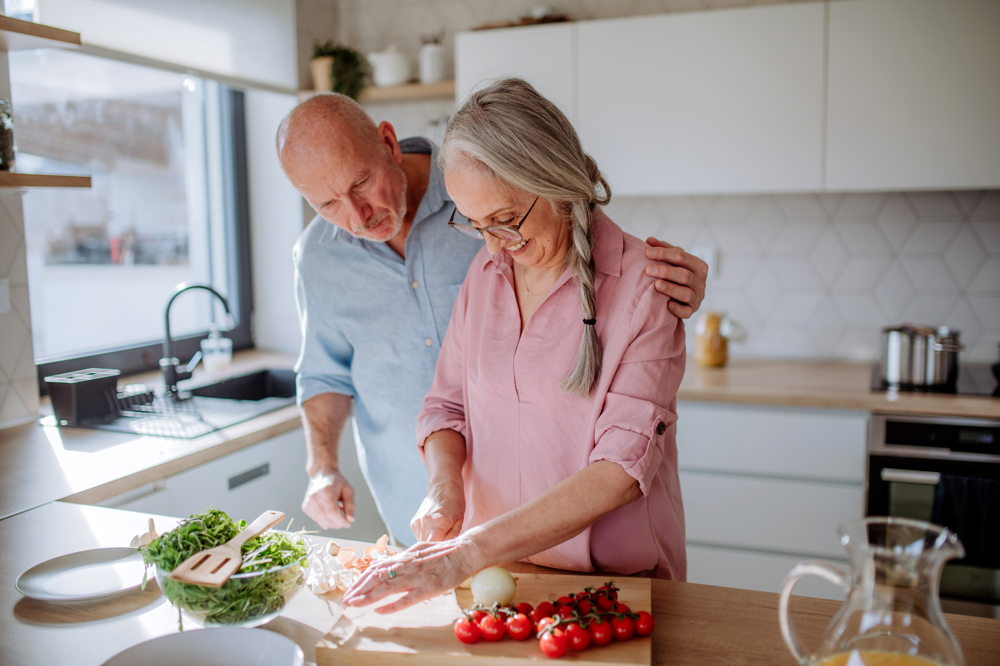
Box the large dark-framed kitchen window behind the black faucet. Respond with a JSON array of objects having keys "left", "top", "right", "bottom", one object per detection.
[{"left": 9, "top": 50, "right": 252, "bottom": 390}]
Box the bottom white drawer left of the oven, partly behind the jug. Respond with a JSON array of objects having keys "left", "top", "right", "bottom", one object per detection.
[{"left": 687, "top": 544, "right": 848, "bottom": 601}]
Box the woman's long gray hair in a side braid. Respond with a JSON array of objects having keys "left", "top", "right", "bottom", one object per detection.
[{"left": 439, "top": 78, "right": 611, "bottom": 397}]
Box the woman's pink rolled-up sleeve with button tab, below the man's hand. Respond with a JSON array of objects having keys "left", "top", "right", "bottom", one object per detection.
[{"left": 590, "top": 285, "right": 684, "bottom": 495}]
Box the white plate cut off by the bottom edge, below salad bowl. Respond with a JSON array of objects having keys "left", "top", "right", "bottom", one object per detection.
[{"left": 103, "top": 627, "right": 305, "bottom": 666}]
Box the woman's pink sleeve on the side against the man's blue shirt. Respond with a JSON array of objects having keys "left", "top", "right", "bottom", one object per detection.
[{"left": 417, "top": 280, "right": 469, "bottom": 452}]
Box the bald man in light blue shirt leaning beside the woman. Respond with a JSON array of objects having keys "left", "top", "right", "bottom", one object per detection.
[{"left": 277, "top": 94, "right": 707, "bottom": 545}]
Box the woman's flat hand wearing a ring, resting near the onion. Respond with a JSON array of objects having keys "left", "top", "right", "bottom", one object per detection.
[{"left": 344, "top": 537, "right": 478, "bottom": 614}]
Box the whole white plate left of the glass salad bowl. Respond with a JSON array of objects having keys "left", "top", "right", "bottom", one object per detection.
[{"left": 14, "top": 548, "right": 146, "bottom": 601}]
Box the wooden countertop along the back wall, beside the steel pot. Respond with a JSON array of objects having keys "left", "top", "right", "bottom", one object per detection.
[{"left": 677, "top": 358, "right": 1000, "bottom": 419}]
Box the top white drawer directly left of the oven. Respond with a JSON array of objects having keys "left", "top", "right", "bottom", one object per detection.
[{"left": 677, "top": 401, "right": 868, "bottom": 483}]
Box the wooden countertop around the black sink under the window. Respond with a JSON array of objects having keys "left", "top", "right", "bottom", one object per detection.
[{"left": 0, "top": 350, "right": 301, "bottom": 519}]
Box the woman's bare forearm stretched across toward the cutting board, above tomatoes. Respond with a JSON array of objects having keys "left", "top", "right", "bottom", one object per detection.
[{"left": 463, "top": 460, "right": 642, "bottom": 570}]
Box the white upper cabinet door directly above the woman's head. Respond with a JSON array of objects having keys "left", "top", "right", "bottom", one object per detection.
[{"left": 455, "top": 23, "right": 576, "bottom": 123}]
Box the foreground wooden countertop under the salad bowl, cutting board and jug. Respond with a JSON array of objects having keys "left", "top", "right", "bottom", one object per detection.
[{"left": 0, "top": 502, "right": 1000, "bottom": 666}]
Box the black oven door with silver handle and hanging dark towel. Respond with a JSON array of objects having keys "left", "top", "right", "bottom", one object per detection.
[{"left": 867, "top": 454, "right": 1000, "bottom": 617}]
